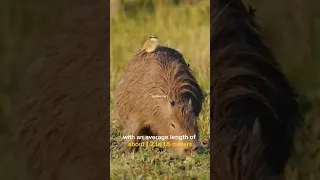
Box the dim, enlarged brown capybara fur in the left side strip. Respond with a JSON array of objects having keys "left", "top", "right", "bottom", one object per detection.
[{"left": 12, "top": 0, "right": 110, "bottom": 180}]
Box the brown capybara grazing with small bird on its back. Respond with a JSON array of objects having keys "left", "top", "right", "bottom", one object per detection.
[{"left": 115, "top": 47, "right": 204, "bottom": 155}]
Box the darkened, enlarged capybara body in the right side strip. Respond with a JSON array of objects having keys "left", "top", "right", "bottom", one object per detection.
[{"left": 210, "top": 0, "right": 302, "bottom": 179}]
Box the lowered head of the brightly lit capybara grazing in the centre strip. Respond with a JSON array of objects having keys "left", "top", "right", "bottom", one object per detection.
[{"left": 158, "top": 99, "right": 200, "bottom": 155}]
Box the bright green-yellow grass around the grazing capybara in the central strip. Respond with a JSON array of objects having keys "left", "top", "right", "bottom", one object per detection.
[{"left": 110, "top": 0, "right": 210, "bottom": 179}]
